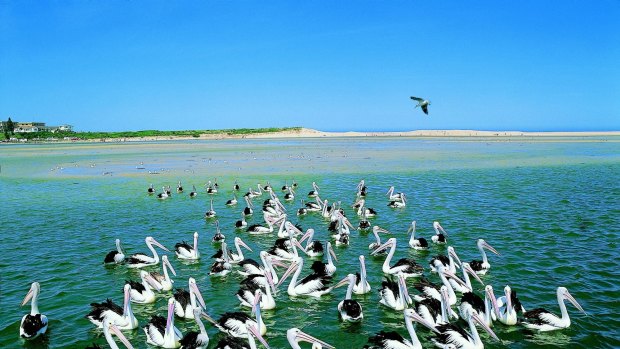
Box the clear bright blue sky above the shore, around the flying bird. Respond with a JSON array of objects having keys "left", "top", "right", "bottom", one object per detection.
[{"left": 0, "top": 0, "right": 620, "bottom": 131}]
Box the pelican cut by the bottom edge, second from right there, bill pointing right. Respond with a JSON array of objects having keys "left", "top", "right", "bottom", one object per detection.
[{"left": 364, "top": 309, "right": 438, "bottom": 349}]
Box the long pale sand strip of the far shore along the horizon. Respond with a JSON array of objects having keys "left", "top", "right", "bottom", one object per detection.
[{"left": 5, "top": 128, "right": 620, "bottom": 144}]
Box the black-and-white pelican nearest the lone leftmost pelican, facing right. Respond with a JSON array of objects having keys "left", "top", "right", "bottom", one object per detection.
[{"left": 86, "top": 284, "right": 138, "bottom": 330}]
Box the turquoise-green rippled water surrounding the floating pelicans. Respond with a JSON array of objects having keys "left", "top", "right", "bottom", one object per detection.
[{"left": 0, "top": 137, "right": 620, "bottom": 348}]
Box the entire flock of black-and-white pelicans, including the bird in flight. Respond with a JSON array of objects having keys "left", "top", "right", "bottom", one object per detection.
[{"left": 19, "top": 178, "right": 585, "bottom": 349}]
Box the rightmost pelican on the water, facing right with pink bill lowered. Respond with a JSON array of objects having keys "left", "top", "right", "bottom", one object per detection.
[{"left": 523, "top": 286, "right": 588, "bottom": 331}]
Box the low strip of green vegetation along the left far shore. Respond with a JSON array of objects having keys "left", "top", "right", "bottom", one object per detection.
[{"left": 1, "top": 127, "right": 301, "bottom": 140}]
